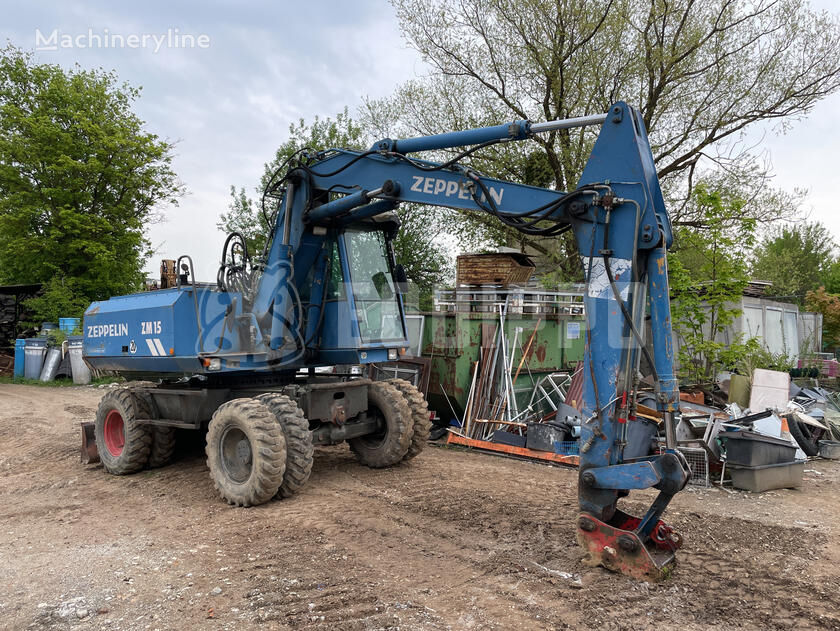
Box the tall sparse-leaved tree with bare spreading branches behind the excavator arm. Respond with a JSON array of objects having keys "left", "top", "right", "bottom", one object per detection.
[{"left": 374, "top": 0, "right": 840, "bottom": 278}]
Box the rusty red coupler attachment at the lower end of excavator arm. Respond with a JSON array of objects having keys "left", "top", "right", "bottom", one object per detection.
[{"left": 577, "top": 511, "right": 682, "bottom": 582}]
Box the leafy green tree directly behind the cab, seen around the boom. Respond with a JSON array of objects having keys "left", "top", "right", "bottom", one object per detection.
[{"left": 217, "top": 108, "right": 450, "bottom": 309}]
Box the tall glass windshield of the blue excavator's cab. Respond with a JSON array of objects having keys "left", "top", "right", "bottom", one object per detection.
[{"left": 344, "top": 230, "right": 405, "bottom": 342}]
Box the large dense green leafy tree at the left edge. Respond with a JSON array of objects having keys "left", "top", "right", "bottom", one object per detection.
[{"left": 0, "top": 46, "right": 182, "bottom": 318}]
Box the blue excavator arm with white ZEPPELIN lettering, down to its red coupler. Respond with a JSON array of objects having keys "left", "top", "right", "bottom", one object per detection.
[{"left": 262, "top": 102, "right": 689, "bottom": 580}]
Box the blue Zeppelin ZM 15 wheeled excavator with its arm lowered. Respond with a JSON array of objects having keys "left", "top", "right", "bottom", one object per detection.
[{"left": 84, "top": 102, "right": 689, "bottom": 579}]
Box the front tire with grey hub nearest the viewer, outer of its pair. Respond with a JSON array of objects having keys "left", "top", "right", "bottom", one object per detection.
[{"left": 206, "top": 399, "right": 286, "bottom": 506}]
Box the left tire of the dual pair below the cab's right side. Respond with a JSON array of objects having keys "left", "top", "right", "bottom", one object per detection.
[{"left": 347, "top": 381, "right": 414, "bottom": 469}]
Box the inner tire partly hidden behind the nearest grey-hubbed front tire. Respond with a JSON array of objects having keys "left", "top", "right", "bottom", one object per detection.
[{"left": 255, "top": 392, "right": 315, "bottom": 497}]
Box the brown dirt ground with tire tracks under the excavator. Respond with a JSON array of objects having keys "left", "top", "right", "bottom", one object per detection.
[{"left": 0, "top": 385, "right": 840, "bottom": 630}]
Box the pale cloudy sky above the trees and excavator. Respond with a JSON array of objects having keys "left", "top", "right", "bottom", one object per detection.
[{"left": 0, "top": 0, "right": 840, "bottom": 280}]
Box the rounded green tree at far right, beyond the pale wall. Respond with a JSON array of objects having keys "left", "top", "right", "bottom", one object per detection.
[{"left": 752, "top": 222, "right": 836, "bottom": 304}]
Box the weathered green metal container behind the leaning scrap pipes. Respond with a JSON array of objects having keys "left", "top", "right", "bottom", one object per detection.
[{"left": 422, "top": 312, "right": 586, "bottom": 419}]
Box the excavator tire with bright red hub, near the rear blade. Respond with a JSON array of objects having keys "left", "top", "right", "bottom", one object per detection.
[{"left": 94, "top": 388, "right": 152, "bottom": 475}]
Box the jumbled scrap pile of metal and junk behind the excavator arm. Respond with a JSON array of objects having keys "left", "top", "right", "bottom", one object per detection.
[{"left": 448, "top": 356, "right": 840, "bottom": 492}]
